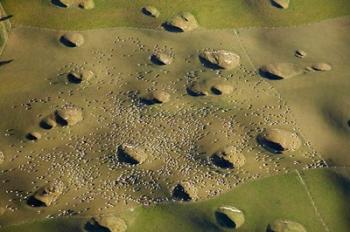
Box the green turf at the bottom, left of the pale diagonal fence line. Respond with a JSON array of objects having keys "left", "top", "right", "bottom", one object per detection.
[{"left": 129, "top": 169, "right": 324, "bottom": 232}]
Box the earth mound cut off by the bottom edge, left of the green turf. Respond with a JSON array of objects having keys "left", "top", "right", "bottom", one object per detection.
[{"left": 84, "top": 216, "right": 127, "bottom": 232}]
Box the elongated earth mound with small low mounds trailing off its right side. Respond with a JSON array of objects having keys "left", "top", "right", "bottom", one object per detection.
[{"left": 259, "top": 63, "right": 303, "bottom": 80}]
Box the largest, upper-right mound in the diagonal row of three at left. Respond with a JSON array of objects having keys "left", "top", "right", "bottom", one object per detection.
[{"left": 55, "top": 106, "right": 83, "bottom": 126}]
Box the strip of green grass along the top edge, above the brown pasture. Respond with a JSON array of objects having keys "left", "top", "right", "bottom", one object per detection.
[{"left": 1, "top": 0, "right": 350, "bottom": 29}]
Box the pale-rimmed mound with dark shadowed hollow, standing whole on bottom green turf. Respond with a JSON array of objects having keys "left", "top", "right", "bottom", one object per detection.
[{"left": 215, "top": 206, "right": 245, "bottom": 229}]
